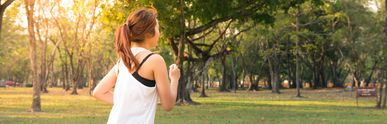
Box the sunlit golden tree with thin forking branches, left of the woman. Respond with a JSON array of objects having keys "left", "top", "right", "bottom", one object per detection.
[{"left": 50, "top": 0, "right": 99, "bottom": 95}]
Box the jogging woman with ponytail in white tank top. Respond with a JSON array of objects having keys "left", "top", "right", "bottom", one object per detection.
[{"left": 93, "top": 8, "right": 180, "bottom": 124}]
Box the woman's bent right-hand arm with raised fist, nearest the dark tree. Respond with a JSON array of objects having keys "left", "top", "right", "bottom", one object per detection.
[{"left": 152, "top": 55, "right": 180, "bottom": 111}]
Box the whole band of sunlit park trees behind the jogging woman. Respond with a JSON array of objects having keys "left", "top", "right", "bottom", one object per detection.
[{"left": 0, "top": 0, "right": 387, "bottom": 108}]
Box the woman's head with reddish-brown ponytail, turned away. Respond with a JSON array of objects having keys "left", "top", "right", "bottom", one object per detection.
[{"left": 115, "top": 8, "right": 160, "bottom": 69}]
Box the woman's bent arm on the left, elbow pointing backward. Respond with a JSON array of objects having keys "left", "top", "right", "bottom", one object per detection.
[{"left": 93, "top": 65, "right": 117, "bottom": 104}]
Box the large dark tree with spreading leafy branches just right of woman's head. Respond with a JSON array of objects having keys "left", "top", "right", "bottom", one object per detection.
[{"left": 104, "top": 0, "right": 324, "bottom": 103}]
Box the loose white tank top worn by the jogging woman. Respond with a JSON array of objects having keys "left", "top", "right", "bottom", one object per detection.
[{"left": 107, "top": 48, "right": 157, "bottom": 124}]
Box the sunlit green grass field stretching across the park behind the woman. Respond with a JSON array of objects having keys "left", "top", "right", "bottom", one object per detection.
[{"left": 0, "top": 88, "right": 387, "bottom": 124}]
